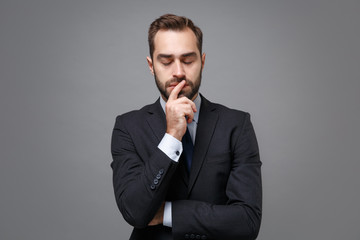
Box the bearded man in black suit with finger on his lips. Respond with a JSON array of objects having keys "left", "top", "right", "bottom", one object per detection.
[{"left": 111, "top": 14, "right": 262, "bottom": 240}]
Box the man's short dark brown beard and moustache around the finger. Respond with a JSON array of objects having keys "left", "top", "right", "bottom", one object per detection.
[{"left": 154, "top": 69, "right": 202, "bottom": 101}]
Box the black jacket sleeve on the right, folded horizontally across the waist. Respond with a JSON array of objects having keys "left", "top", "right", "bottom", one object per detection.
[{"left": 172, "top": 114, "right": 262, "bottom": 240}]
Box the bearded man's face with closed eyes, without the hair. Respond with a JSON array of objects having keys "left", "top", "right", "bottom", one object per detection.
[{"left": 147, "top": 28, "right": 205, "bottom": 101}]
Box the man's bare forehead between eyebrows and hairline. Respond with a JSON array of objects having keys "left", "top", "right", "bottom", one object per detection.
[{"left": 154, "top": 28, "right": 200, "bottom": 56}]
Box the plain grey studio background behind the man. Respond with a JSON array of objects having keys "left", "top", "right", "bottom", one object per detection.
[{"left": 0, "top": 0, "right": 360, "bottom": 240}]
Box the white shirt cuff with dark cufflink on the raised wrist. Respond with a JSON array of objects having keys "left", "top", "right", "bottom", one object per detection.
[{"left": 158, "top": 133, "right": 183, "bottom": 162}]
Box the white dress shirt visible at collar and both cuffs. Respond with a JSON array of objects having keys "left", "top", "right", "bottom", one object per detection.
[{"left": 158, "top": 94, "right": 201, "bottom": 227}]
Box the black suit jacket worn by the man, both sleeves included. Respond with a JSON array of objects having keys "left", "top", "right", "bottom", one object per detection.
[{"left": 111, "top": 96, "right": 262, "bottom": 240}]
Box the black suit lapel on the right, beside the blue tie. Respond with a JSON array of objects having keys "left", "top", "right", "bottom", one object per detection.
[{"left": 188, "top": 95, "right": 218, "bottom": 194}]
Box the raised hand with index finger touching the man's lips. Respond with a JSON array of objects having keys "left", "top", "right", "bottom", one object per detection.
[{"left": 165, "top": 80, "right": 197, "bottom": 141}]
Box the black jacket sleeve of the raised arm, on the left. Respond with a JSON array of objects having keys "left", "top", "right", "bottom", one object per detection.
[{"left": 111, "top": 116, "right": 177, "bottom": 228}]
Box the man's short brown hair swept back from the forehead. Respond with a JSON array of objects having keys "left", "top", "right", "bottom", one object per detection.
[{"left": 148, "top": 14, "right": 202, "bottom": 58}]
